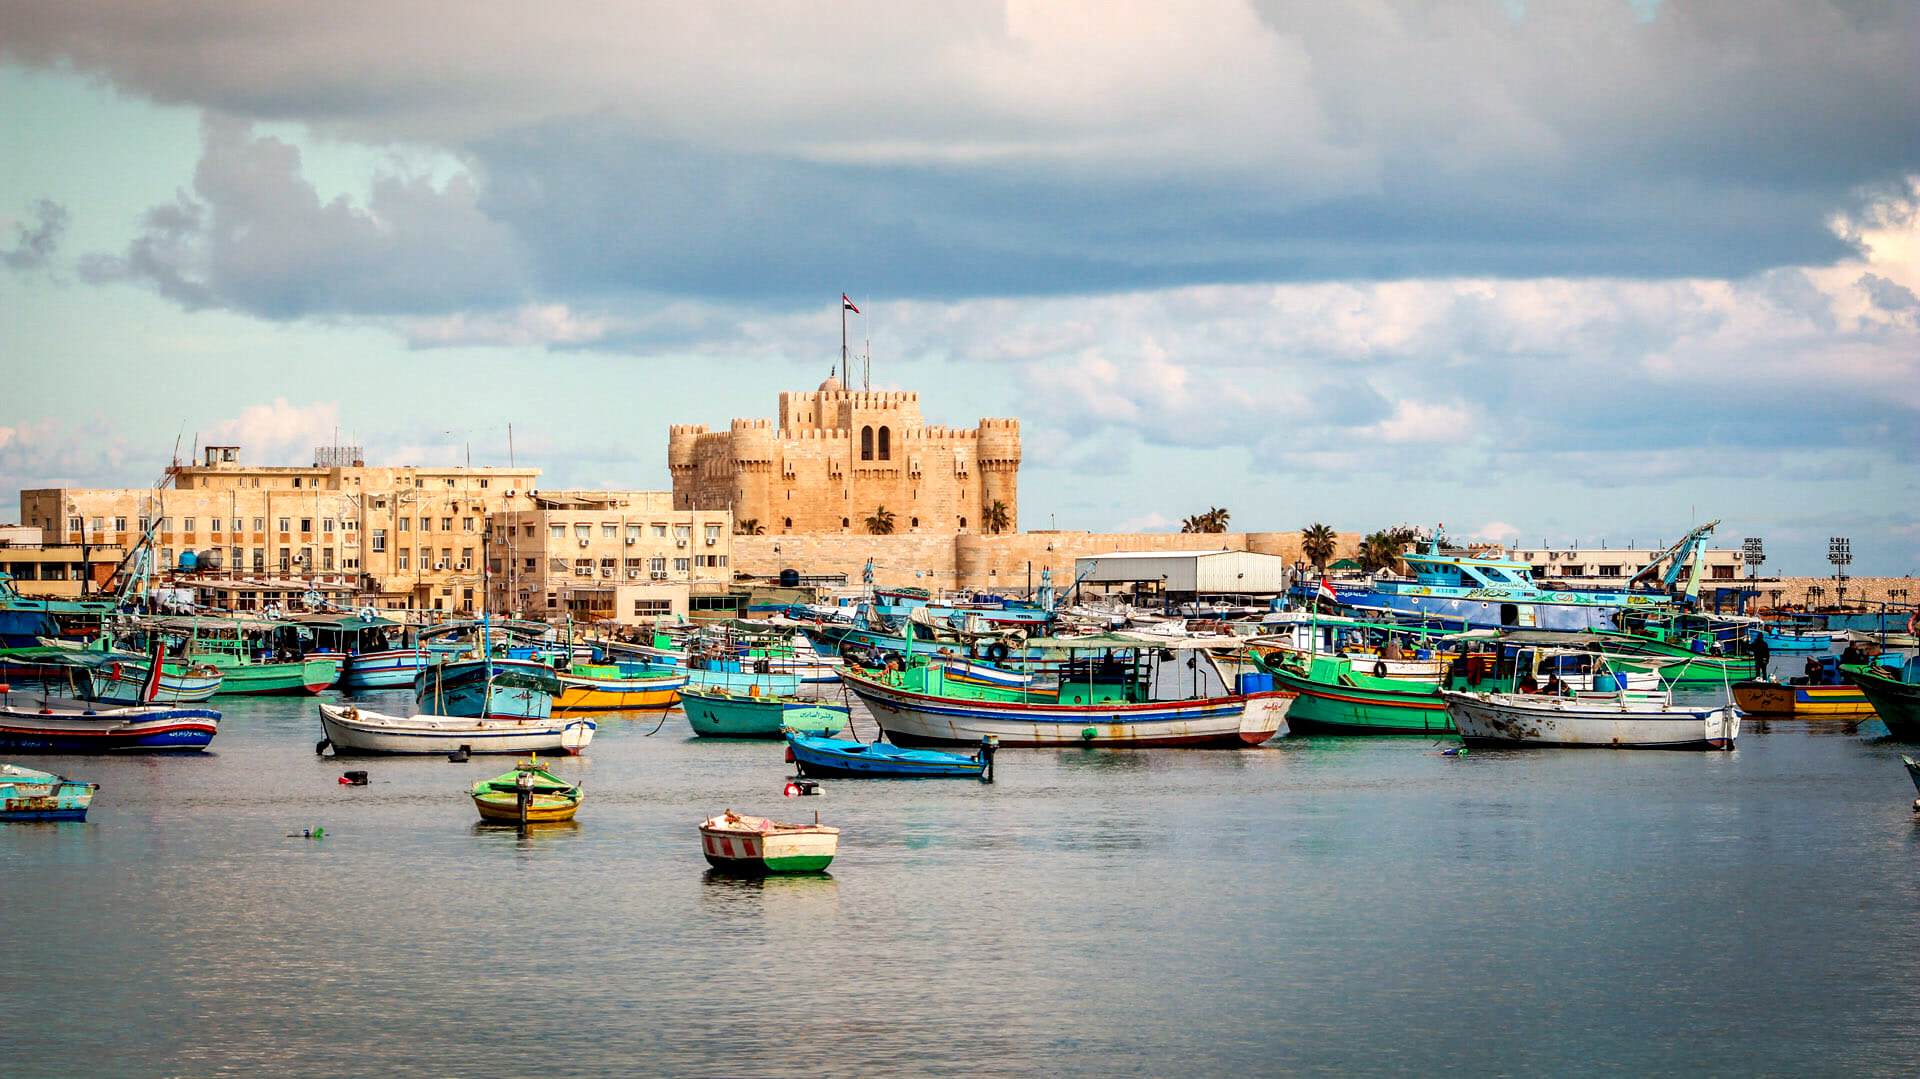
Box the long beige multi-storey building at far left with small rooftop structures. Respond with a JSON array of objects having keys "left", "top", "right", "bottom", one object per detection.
[{"left": 19, "top": 445, "right": 540, "bottom": 611}]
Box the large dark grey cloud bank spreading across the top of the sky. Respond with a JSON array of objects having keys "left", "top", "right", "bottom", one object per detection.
[{"left": 0, "top": 0, "right": 1920, "bottom": 317}]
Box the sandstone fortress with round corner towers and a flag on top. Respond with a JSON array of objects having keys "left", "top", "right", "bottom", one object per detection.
[{"left": 666, "top": 378, "right": 1020, "bottom": 536}]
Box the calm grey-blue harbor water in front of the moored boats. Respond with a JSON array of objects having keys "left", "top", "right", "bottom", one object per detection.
[{"left": 0, "top": 693, "right": 1920, "bottom": 1077}]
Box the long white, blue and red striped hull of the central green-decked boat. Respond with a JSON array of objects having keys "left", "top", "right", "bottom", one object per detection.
[{"left": 845, "top": 672, "right": 1292, "bottom": 749}]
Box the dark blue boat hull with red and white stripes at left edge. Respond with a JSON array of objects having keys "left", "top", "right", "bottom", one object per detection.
[{"left": 0, "top": 691, "right": 221, "bottom": 753}]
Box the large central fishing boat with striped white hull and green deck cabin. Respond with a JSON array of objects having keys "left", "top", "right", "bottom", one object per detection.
[{"left": 843, "top": 637, "right": 1290, "bottom": 749}]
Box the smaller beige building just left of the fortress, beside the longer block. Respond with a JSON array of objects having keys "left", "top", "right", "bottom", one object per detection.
[{"left": 488, "top": 492, "right": 733, "bottom": 622}]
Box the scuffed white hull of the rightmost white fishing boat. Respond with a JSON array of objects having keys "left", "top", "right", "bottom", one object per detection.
[{"left": 1440, "top": 689, "right": 1740, "bottom": 749}]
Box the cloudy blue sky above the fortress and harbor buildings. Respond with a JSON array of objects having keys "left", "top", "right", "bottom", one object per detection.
[{"left": 0, "top": 0, "right": 1920, "bottom": 576}]
